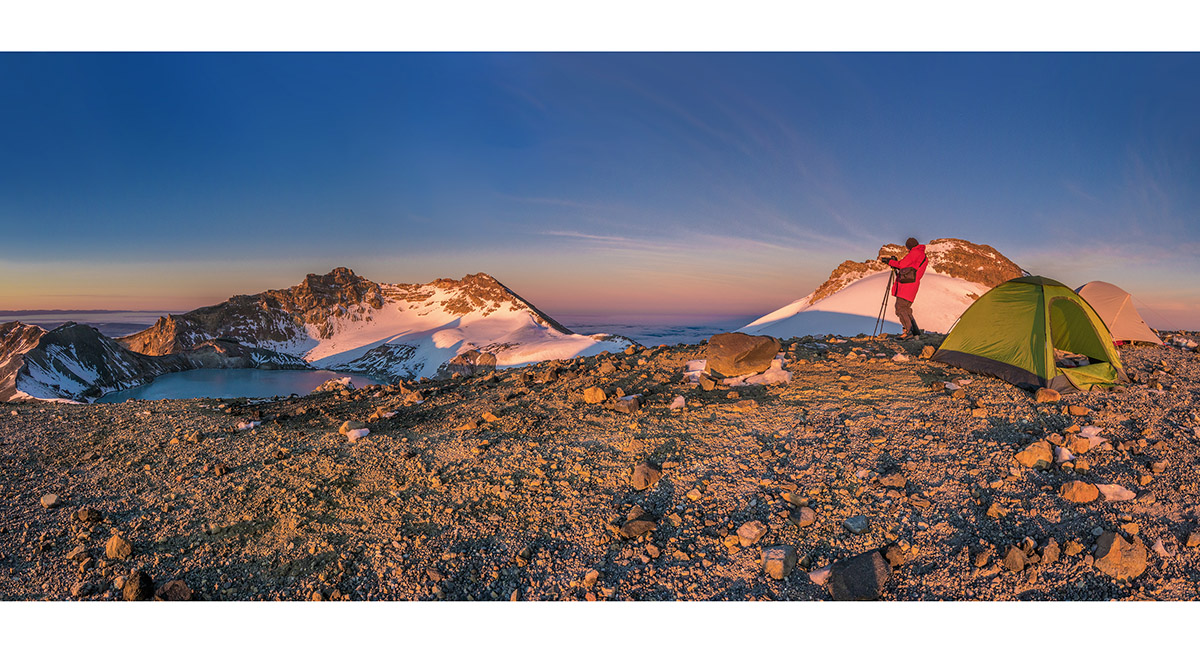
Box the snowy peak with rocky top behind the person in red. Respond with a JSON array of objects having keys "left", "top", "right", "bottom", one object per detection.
[{"left": 739, "top": 239, "right": 1024, "bottom": 338}]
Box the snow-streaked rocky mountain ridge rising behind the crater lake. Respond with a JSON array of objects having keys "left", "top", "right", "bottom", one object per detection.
[{"left": 120, "top": 267, "right": 630, "bottom": 379}]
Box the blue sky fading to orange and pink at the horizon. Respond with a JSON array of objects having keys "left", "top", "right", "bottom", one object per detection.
[{"left": 0, "top": 53, "right": 1200, "bottom": 329}]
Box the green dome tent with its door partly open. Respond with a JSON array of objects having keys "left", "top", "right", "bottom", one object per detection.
[{"left": 931, "top": 276, "right": 1128, "bottom": 392}]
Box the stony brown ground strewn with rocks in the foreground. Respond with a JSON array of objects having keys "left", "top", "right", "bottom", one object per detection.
[{"left": 0, "top": 336, "right": 1200, "bottom": 601}]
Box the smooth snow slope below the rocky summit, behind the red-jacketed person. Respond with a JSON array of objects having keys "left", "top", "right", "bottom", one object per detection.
[{"left": 738, "top": 271, "right": 989, "bottom": 338}]
